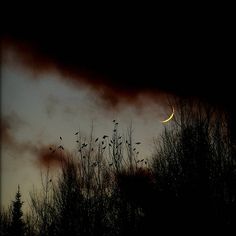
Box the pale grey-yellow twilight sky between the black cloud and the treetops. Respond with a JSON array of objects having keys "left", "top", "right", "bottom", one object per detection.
[{"left": 1, "top": 49, "right": 171, "bottom": 210}]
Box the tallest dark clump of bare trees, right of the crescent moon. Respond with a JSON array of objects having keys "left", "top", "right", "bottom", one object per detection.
[{"left": 153, "top": 100, "right": 236, "bottom": 232}]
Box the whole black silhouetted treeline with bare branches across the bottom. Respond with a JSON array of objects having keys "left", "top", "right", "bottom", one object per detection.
[{"left": 0, "top": 101, "right": 236, "bottom": 236}]
